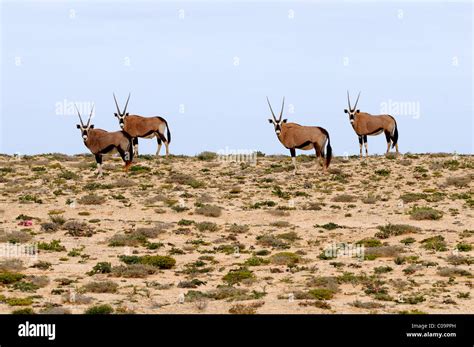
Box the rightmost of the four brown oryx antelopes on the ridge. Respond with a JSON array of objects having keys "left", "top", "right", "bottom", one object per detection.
[{"left": 344, "top": 91, "right": 398, "bottom": 158}]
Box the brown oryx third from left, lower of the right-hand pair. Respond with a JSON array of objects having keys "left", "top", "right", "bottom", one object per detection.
[{"left": 267, "top": 97, "right": 332, "bottom": 174}]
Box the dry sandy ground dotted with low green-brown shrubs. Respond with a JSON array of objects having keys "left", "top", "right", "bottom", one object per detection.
[{"left": 0, "top": 154, "right": 474, "bottom": 314}]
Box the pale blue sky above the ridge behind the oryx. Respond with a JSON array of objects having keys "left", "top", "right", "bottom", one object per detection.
[{"left": 0, "top": 1, "right": 474, "bottom": 155}]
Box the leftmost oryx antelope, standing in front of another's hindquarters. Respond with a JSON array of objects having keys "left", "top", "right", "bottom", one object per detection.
[{"left": 76, "top": 106, "right": 133, "bottom": 177}]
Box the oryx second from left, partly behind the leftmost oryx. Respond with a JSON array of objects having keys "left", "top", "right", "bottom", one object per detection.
[{"left": 114, "top": 94, "right": 171, "bottom": 157}]
